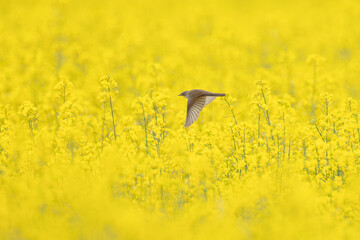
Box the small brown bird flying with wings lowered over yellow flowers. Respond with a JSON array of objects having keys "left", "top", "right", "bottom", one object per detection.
[{"left": 179, "top": 89, "right": 226, "bottom": 128}]
